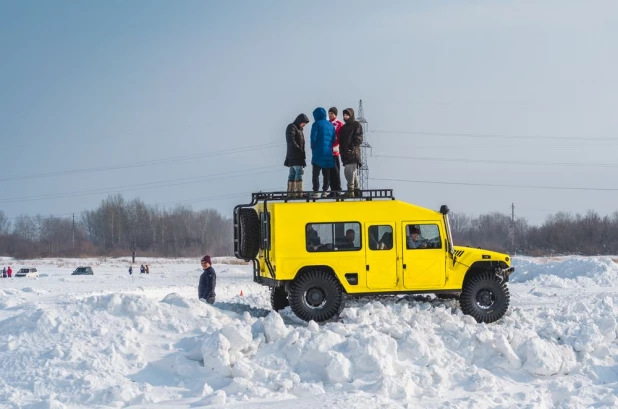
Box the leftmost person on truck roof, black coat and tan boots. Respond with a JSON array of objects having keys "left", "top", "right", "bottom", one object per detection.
[{"left": 284, "top": 114, "right": 309, "bottom": 196}]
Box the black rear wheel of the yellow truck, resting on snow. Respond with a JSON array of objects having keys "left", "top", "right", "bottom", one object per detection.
[{"left": 289, "top": 270, "right": 343, "bottom": 322}]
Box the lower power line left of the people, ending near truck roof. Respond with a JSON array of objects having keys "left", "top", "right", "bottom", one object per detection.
[{"left": 0, "top": 166, "right": 281, "bottom": 203}]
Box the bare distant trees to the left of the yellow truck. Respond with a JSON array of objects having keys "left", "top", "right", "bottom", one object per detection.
[{"left": 0, "top": 195, "right": 233, "bottom": 258}]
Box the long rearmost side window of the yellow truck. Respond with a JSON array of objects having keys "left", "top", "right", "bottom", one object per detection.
[{"left": 306, "top": 222, "right": 361, "bottom": 252}]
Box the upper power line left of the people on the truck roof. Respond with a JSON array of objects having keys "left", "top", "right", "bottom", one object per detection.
[{"left": 0, "top": 142, "right": 285, "bottom": 182}]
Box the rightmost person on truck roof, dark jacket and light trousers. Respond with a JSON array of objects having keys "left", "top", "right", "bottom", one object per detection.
[{"left": 339, "top": 108, "right": 363, "bottom": 197}]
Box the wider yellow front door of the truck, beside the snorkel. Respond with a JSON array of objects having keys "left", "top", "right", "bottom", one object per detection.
[{"left": 400, "top": 221, "right": 446, "bottom": 290}]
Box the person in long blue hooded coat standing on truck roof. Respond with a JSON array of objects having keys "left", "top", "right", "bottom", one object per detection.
[{"left": 311, "top": 107, "right": 336, "bottom": 197}]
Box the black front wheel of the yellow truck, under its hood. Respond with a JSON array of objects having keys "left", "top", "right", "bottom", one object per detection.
[{"left": 459, "top": 271, "right": 511, "bottom": 323}]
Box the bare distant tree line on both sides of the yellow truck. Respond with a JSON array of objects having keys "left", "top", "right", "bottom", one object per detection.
[{"left": 0, "top": 201, "right": 618, "bottom": 258}]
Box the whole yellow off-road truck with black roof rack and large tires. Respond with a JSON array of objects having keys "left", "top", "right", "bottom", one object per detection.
[{"left": 234, "top": 189, "right": 514, "bottom": 323}]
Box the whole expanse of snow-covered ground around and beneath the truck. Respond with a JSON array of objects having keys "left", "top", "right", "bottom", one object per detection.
[{"left": 0, "top": 257, "right": 618, "bottom": 409}]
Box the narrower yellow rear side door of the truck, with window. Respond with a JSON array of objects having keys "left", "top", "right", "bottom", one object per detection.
[{"left": 365, "top": 222, "right": 399, "bottom": 290}]
